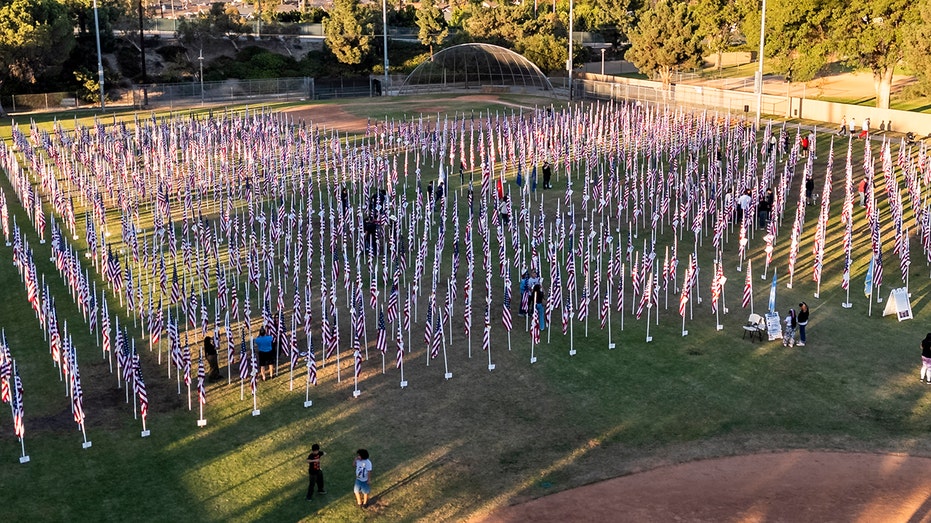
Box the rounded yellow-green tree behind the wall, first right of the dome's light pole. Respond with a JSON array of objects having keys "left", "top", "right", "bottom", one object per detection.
[{"left": 626, "top": 0, "right": 701, "bottom": 87}]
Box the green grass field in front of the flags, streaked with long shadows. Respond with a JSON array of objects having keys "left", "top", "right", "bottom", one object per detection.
[{"left": 0, "top": 98, "right": 931, "bottom": 521}]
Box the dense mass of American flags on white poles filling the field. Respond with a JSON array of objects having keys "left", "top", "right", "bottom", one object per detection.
[{"left": 0, "top": 104, "right": 931, "bottom": 454}]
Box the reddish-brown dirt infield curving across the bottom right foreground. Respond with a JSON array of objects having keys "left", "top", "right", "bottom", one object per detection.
[{"left": 479, "top": 451, "right": 931, "bottom": 523}]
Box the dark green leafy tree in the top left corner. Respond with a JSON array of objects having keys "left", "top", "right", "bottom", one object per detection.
[{"left": 0, "top": 0, "right": 75, "bottom": 89}]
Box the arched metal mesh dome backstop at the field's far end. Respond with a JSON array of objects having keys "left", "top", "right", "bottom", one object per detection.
[{"left": 398, "top": 43, "right": 553, "bottom": 94}]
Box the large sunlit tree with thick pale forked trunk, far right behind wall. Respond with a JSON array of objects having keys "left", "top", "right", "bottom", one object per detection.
[{"left": 832, "top": 0, "right": 927, "bottom": 109}]
